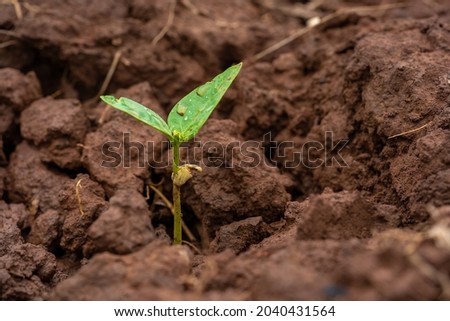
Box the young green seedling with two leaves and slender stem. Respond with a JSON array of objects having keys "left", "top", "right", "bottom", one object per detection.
[{"left": 100, "top": 63, "right": 242, "bottom": 244}]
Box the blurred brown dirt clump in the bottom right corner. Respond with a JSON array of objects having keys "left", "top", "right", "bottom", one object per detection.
[{"left": 336, "top": 230, "right": 450, "bottom": 300}]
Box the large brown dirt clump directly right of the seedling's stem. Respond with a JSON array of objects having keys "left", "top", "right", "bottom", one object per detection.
[{"left": 183, "top": 120, "right": 290, "bottom": 237}]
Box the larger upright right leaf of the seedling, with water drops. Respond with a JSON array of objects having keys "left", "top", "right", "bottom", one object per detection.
[{"left": 167, "top": 63, "right": 242, "bottom": 142}]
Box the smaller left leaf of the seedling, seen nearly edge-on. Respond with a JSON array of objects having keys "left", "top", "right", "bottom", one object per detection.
[{"left": 100, "top": 96, "right": 173, "bottom": 140}]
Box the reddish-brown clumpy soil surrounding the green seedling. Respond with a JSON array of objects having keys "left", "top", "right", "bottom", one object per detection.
[{"left": 0, "top": 0, "right": 450, "bottom": 300}]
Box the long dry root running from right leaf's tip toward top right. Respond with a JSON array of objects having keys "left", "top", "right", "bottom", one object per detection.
[{"left": 250, "top": 3, "right": 407, "bottom": 62}]
